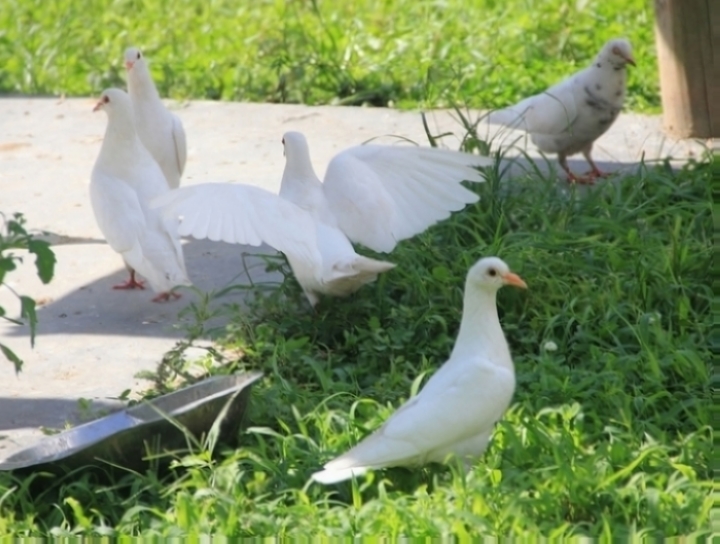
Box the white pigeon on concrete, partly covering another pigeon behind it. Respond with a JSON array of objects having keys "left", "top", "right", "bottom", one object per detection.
[{"left": 90, "top": 89, "right": 190, "bottom": 302}]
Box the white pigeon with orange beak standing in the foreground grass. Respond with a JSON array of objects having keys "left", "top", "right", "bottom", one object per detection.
[{"left": 312, "top": 257, "right": 527, "bottom": 484}]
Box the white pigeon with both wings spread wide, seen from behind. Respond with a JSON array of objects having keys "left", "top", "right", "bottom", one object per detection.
[{"left": 153, "top": 132, "right": 489, "bottom": 306}]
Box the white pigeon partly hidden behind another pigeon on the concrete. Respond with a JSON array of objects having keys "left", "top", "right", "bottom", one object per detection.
[{"left": 125, "top": 47, "right": 187, "bottom": 189}]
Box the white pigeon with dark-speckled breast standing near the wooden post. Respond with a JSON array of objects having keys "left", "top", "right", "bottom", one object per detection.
[{"left": 488, "top": 39, "right": 635, "bottom": 184}]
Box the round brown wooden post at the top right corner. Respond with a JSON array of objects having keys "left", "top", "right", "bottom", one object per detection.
[{"left": 655, "top": 0, "right": 720, "bottom": 138}]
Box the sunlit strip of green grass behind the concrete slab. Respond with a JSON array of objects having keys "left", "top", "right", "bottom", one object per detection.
[{"left": 0, "top": 0, "right": 660, "bottom": 111}]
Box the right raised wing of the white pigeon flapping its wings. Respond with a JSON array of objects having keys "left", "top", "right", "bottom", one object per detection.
[{"left": 323, "top": 145, "right": 492, "bottom": 252}]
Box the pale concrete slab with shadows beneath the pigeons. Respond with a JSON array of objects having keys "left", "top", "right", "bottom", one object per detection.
[{"left": 0, "top": 98, "right": 703, "bottom": 458}]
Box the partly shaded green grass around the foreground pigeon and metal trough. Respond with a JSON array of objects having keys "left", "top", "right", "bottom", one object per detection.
[{"left": 0, "top": 144, "right": 713, "bottom": 537}]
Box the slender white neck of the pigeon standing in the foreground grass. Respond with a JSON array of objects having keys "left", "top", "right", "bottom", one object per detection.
[{"left": 451, "top": 286, "right": 513, "bottom": 370}]
